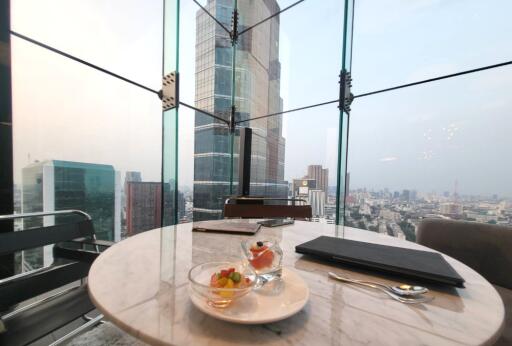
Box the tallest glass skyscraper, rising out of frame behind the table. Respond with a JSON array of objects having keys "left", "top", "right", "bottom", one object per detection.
[{"left": 193, "top": 0, "right": 288, "bottom": 220}]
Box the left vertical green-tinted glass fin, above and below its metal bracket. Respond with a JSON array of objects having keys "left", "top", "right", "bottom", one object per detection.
[{"left": 164, "top": 0, "right": 180, "bottom": 226}]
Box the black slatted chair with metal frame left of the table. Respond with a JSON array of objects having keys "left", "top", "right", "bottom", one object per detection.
[{"left": 0, "top": 210, "right": 112, "bottom": 346}]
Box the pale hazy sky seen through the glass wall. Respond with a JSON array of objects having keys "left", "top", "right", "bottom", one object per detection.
[{"left": 11, "top": 0, "right": 512, "bottom": 197}]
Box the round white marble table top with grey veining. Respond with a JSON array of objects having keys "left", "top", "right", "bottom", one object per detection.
[{"left": 89, "top": 222, "right": 504, "bottom": 345}]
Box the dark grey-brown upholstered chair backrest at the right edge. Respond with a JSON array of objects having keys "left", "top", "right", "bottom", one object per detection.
[{"left": 416, "top": 219, "right": 512, "bottom": 288}]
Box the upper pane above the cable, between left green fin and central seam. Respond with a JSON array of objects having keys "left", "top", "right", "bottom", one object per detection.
[{"left": 180, "top": 0, "right": 233, "bottom": 119}]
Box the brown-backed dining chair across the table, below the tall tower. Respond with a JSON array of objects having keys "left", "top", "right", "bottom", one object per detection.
[{"left": 224, "top": 196, "right": 312, "bottom": 220}]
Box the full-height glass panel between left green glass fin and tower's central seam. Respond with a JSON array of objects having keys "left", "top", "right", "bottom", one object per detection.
[{"left": 179, "top": 0, "right": 238, "bottom": 221}]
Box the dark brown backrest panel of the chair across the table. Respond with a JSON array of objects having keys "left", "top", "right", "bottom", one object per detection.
[{"left": 224, "top": 203, "right": 312, "bottom": 219}]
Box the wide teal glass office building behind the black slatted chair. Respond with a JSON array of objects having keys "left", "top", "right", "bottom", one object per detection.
[{"left": 22, "top": 160, "right": 121, "bottom": 268}]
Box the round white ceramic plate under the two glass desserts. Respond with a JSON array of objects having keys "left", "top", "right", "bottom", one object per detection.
[{"left": 189, "top": 268, "right": 309, "bottom": 324}]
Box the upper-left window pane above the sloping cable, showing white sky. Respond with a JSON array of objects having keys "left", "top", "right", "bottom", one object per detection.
[{"left": 11, "top": 0, "right": 163, "bottom": 90}]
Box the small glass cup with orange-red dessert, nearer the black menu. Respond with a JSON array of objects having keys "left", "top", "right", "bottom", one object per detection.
[{"left": 241, "top": 239, "right": 283, "bottom": 285}]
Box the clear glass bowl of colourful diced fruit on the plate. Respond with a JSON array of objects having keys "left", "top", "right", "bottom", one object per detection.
[{"left": 188, "top": 262, "right": 256, "bottom": 308}]
